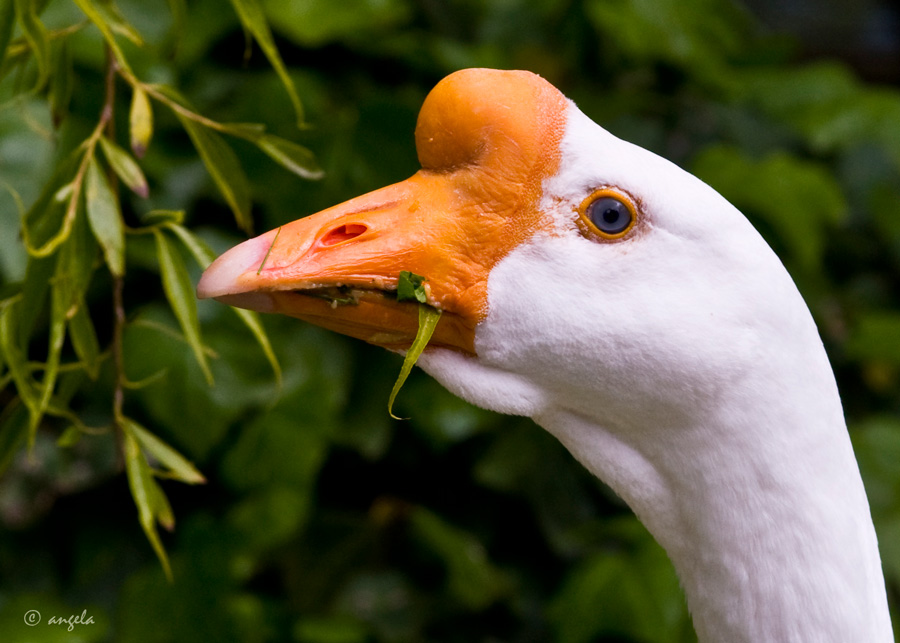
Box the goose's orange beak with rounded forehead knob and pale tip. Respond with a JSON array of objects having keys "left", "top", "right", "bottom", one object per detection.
[{"left": 197, "top": 69, "right": 566, "bottom": 355}]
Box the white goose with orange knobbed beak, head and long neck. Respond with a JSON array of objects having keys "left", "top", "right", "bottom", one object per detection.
[{"left": 198, "top": 69, "right": 893, "bottom": 643}]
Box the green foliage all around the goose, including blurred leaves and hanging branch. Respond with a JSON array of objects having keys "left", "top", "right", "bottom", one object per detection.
[{"left": 0, "top": 0, "right": 900, "bottom": 643}]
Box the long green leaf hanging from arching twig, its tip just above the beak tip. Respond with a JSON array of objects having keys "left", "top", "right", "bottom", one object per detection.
[{"left": 176, "top": 112, "right": 253, "bottom": 234}]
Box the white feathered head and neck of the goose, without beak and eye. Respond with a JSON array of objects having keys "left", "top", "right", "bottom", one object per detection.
[{"left": 420, "top": 105, "right": 893, "bottom": 643}]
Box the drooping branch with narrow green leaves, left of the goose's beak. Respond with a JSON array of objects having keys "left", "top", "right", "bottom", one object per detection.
[{"left": 0, "top": 0, "right": 306, "bottom": 578}]
